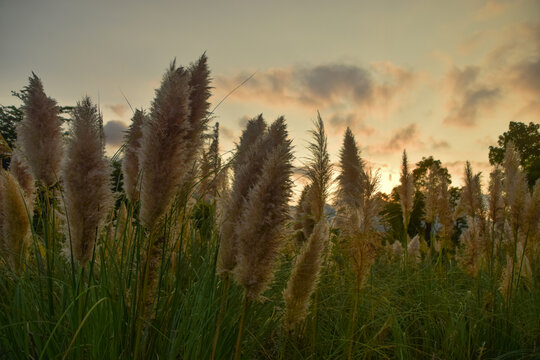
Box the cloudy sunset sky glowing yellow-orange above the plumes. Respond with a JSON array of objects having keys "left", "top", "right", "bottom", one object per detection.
[{"left": 0, "top": 0, "right": 540, "bottom": 192}]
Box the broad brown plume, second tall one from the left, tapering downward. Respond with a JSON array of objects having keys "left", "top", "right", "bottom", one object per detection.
[{"left": 62, "top": 97, "right": 113, "bottom": 265}]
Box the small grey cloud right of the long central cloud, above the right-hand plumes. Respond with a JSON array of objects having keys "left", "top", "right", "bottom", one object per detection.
[{"left": 443, "top": 66, "right": 501, "bottom": 127}]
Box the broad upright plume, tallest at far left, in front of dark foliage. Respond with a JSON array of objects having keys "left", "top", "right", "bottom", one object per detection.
[{"left": 17, "top": 74, "right": 62, "bottom": 186}]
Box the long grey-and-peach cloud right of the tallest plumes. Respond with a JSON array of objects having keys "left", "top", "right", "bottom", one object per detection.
[{"left": 215, "top": 62, "right": 417, "bottom": 127}]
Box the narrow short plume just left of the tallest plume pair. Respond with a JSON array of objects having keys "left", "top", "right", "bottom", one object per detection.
[{"left": 122, "top": 109, "right": 145, "bottom": 202}]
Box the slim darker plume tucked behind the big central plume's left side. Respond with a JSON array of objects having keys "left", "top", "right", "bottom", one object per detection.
[{"left": 217, "top": 115, "right": 268, "bottom": 274}]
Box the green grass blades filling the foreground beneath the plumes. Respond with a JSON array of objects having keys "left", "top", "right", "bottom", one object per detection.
[{"left": 0, "top": 203, "right": 540, "bottom": 359}]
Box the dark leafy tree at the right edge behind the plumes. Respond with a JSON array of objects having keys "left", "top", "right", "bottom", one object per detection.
[{"left": 489, "top": 121, "right": 540, "bottom": 187}]
